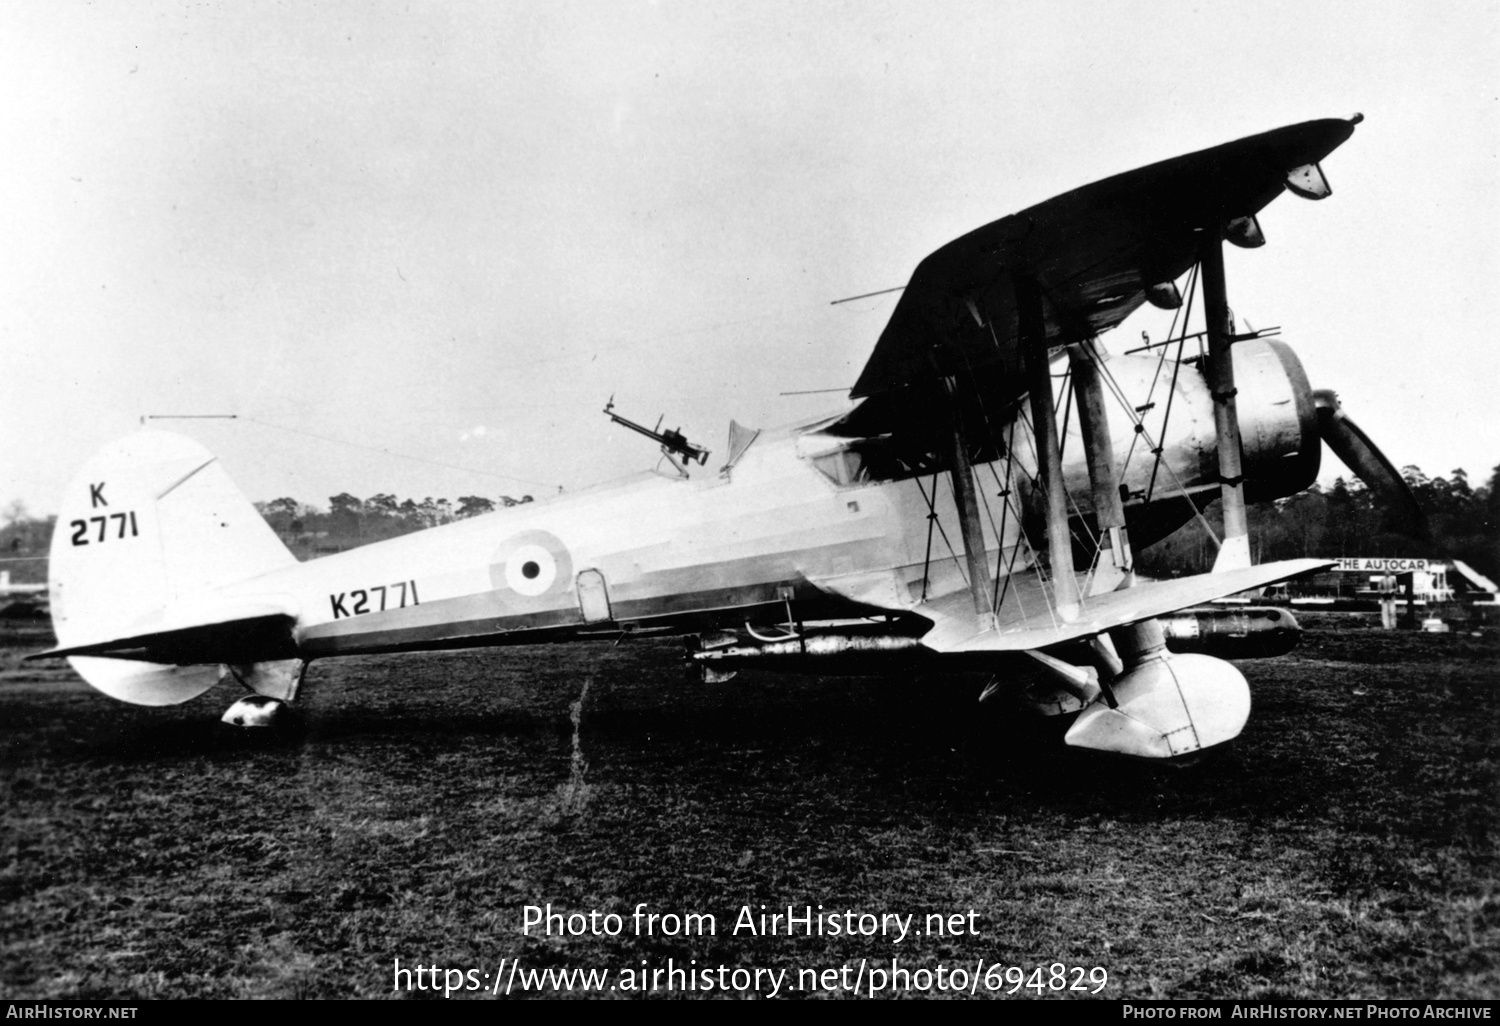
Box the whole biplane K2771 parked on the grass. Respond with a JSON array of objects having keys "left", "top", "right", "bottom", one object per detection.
[{"left": 42, "top": 116, "right": 1400, "bottom": 759}]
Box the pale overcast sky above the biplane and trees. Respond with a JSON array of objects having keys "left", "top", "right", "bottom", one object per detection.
[{"left": 0, "top": 0, "right": 1500, "bottom": 513}]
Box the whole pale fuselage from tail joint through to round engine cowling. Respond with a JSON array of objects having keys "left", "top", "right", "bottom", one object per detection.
[{"left": 225, "top": 342, "right": 1317, "bottom": 659}]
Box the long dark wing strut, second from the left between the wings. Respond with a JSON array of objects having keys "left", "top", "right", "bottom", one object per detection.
[{"left": 1016, "top": 278, "right": 1080, "bottom": 623}]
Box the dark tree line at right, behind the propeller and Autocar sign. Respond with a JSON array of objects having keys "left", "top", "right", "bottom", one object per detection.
[{"left": 1140, "top": 467, "right": 1500, "bottom": 579}]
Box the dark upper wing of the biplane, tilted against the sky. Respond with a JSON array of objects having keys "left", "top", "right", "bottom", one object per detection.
[{"left": 840, "top": 117, "right": 1359, "bottom": 438}]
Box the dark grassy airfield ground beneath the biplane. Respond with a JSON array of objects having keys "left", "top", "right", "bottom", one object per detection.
[{"left": 0, "top": 617, "right": 1500, "bottom": 999}]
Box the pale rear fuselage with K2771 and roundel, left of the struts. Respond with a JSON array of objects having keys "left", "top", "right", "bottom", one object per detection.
[{"left": 223, "top": 428, "right": 972, "bottom": 657}]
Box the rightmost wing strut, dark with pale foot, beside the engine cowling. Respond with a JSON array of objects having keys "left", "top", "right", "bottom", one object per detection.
[{"left": 1199, "top": 227, "right": 1251, "bottom": 572}]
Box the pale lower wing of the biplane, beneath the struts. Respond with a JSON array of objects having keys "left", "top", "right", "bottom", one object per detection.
[{"left": 914, "top": 560, "right": 1334, "bottom": 653}]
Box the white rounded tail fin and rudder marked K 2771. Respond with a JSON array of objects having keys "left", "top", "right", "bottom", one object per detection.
[{"left": 48, "top": 431, "right": 297, "bottom": 705}]
